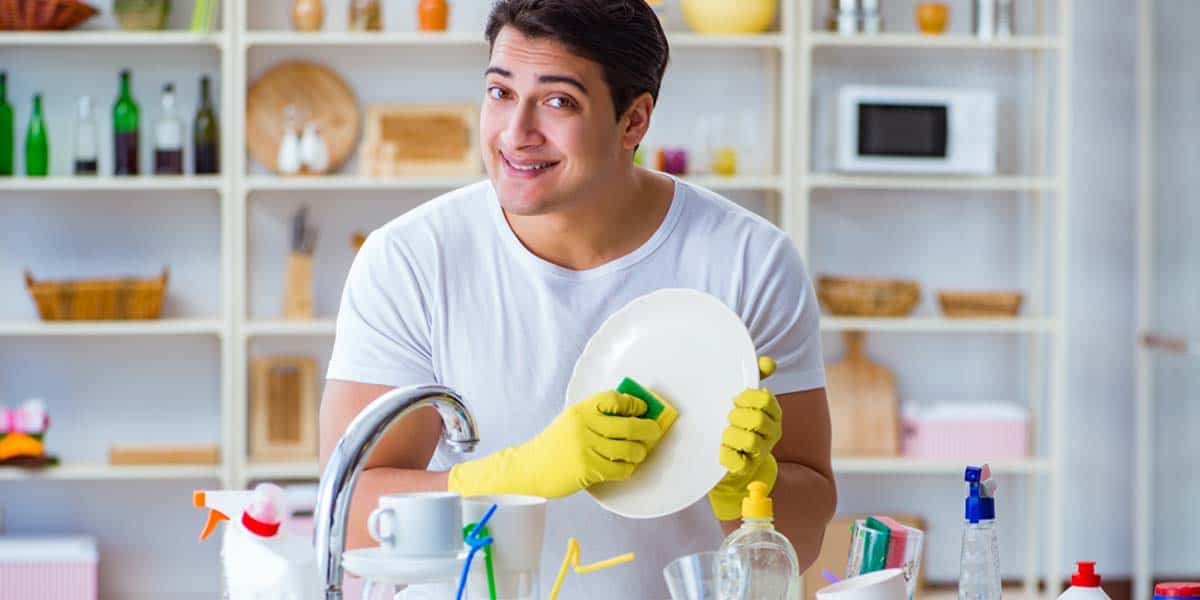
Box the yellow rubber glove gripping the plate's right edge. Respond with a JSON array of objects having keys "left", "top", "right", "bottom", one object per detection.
[{"left": 708, "top": 356, "right": 784, "bottom": 521}]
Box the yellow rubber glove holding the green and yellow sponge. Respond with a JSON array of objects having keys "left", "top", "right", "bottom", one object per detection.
[{"left": 449, "top": 391, "right": 662, "bottom": 498}]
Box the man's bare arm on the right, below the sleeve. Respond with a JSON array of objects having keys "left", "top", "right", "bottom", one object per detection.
[{"left": 721, "top": 388, "right": 838, "bottom": 572}]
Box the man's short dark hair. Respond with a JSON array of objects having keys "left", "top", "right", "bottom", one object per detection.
[{"left": 486, "top": 0, "right": 671, "bottom": 119}]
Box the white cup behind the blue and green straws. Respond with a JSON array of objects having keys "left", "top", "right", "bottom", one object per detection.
[{"left": 462, "top": 494, "right": 546, "bottom": 599}]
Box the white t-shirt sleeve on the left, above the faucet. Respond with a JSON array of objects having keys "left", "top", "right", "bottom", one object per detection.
[{"left": 325, "top": 230, "right": 438, "bottom": 388}]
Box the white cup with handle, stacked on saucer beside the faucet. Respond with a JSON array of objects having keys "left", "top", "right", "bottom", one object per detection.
[{"left": 367, "top": 492, "right": 463, "bottom": 558}]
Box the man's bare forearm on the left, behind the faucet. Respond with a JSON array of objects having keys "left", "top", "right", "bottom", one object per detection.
[{"left": 320, "top": 379, "right": 446, "bottom": 550}]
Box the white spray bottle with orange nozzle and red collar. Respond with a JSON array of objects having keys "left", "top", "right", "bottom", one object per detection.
[{"left": 192, "top": 484, "right": 322, "bottom": 600}]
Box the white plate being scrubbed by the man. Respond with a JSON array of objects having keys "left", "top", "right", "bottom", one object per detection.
[{"left": 566, "top": 288, "right": 758, "bottom": 518}]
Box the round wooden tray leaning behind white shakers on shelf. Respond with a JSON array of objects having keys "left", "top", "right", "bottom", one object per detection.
[{"left": 246, "top": 61, "right": 361, "bottom": 173}]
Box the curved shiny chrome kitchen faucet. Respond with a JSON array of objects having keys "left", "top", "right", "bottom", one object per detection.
[{"left": 314, "top": 385, "right": 479, "bottom": 600}]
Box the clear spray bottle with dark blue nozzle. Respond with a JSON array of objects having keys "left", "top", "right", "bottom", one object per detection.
[{"left": 959, "top": 466, "right": 1000, "bottom": 600}]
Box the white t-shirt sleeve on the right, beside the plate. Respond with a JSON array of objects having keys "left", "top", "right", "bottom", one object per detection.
[{"left": 743, "top": 236, "right": 824, "bottom": 394}]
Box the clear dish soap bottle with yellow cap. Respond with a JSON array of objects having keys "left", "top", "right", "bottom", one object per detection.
[{"left": 720, "top": 481, "right": 800, "bottom": 600}]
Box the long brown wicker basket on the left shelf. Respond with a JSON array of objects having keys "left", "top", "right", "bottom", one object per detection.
[{"left": 25, "top": 269, "right": 167, "bottom": 320}]
